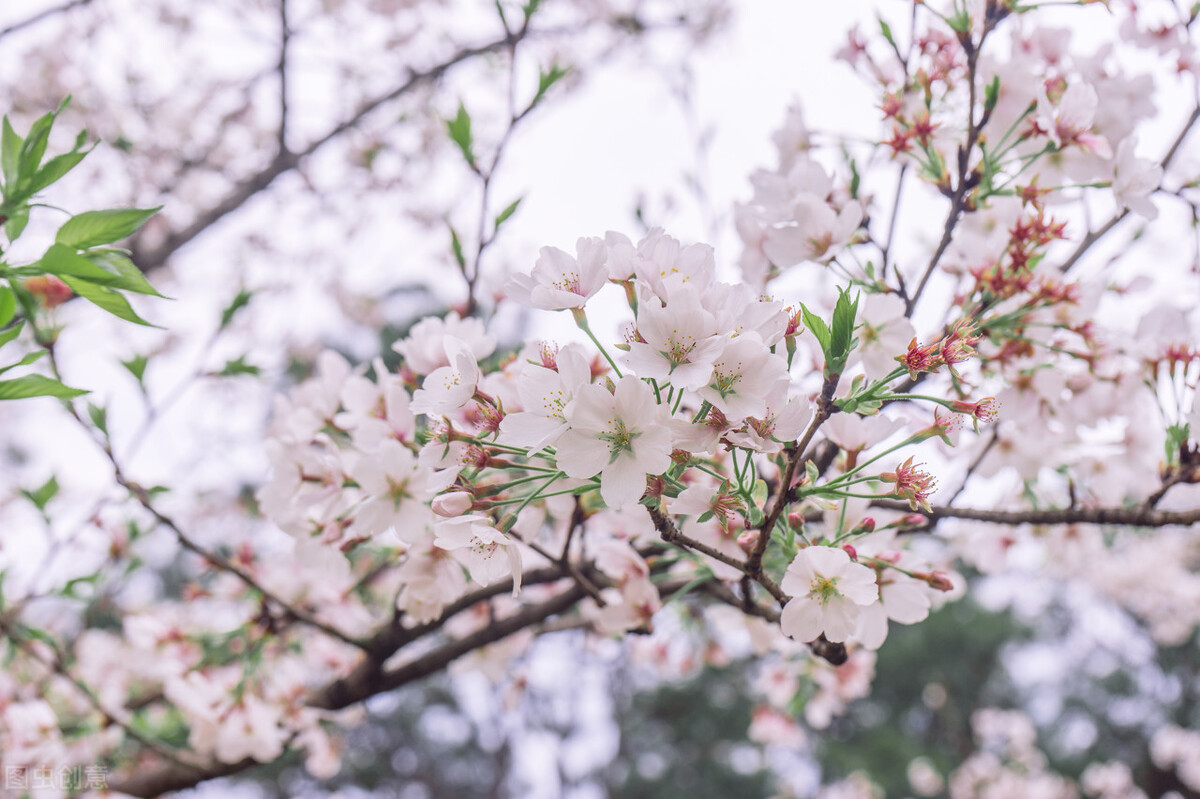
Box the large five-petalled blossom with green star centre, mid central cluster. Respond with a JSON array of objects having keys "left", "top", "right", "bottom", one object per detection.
[{"left": 558, "top": 376, "right": 671, "bottom": 507}]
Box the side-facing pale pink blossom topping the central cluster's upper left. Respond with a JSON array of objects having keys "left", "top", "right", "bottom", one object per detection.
[{"left": 506, "top": 239, "right": 608, "bottom": 311}]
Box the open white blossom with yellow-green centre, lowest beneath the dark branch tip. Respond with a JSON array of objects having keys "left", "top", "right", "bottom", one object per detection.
[{"left": 779, "top": 546, "right": 880, "bottom": 642}]
